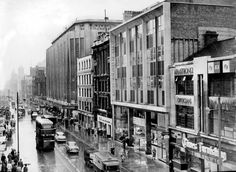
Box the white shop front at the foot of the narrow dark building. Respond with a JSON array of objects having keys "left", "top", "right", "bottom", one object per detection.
[{"left": 97, "top": 115, "right": 112, "bottom": 137}]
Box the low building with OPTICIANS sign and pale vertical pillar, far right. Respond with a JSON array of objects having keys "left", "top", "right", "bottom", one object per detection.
[{"left": 169, "top": 38, "right": 236, "bottom": 171}]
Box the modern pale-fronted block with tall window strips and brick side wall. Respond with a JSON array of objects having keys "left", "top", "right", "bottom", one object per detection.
[{"left": 110, "top": 0, "right": 236, "bottom": 163}]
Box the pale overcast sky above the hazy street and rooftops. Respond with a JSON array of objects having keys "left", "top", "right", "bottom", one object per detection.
[{"left": 0, "top": 0, "right": 158, "bottom": 89}]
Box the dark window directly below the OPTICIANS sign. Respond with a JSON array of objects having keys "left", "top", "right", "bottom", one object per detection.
[{"left": 176, "top": 106, "right": 194, "bottom": 129}]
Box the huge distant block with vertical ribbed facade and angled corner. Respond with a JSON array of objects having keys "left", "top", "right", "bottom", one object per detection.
[{"left": 46, "top": 19, "right": 120, "bottom": 115}]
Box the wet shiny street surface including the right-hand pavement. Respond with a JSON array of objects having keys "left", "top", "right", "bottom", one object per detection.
[{"left": 7, "top": 109, "right": 168, "bottom": 172}]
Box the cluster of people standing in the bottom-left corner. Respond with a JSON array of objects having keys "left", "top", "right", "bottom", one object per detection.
[{"left": 1, "top": 149, "right": 28, "bottom": 172}]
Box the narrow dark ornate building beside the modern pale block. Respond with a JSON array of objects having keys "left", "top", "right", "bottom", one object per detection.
[{"left": 92, "top": 33, "right": 113, "bottom": 137}]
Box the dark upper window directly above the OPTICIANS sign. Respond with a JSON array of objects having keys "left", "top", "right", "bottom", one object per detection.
[{"left": 175, "top": 76, "right": 193, "bottom": 95}]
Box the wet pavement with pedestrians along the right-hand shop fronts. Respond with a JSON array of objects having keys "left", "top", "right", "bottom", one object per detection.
[{"left": 60, "top": 126, "right": 169, "bottom": 172}]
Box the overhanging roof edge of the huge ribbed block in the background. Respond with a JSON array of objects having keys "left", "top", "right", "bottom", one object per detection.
[{"left": 51, "top": 19, "right": 122, "bottom": 44}]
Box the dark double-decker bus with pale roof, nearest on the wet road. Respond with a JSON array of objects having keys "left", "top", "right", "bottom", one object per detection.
[{"left": 36, "top": 117, "right": 56, "bottom": 150}]
